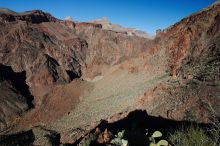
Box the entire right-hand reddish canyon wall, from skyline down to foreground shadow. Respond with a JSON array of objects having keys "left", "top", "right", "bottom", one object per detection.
[{"left": 146, "top": 1, "right": 220, "bottom": 122}]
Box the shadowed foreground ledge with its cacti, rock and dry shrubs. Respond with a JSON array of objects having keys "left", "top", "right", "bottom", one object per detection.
[{"left": 78, "top": 106, "right": 220, "bottom": 146}]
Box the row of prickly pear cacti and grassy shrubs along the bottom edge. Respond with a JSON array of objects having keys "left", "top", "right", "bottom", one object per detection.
[{"left": 78, "top": 126, "right": 220, "bottom": 146}]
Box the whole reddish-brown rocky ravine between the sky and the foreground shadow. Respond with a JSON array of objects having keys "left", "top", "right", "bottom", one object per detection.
[{"left": 0, "top": 1, "right": 220, "bottom": 145}]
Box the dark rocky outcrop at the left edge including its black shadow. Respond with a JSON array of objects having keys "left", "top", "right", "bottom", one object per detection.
[{"left": 0, "top": 64, "right": 33, "bottom": 132}]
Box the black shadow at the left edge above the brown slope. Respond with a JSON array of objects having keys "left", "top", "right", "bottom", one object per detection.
[{"left": 0, "top": 64, "right": 34, "bottom": 108}]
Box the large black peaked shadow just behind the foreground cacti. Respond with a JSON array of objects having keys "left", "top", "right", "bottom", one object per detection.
[{"left": 87, "top": 110, "right": 211, "bottom": 146}]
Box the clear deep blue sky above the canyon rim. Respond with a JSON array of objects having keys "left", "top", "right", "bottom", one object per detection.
[{"left": 0, "top": 0, "right": 216, "bottom": 35}]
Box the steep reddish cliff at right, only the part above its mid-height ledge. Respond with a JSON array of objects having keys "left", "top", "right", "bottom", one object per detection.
[{"left": 157, "top": 2, "right": 220, "bottom": 81}]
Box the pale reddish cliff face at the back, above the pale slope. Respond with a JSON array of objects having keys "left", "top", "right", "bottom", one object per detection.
[{"left": 76, "top": 24, "right": 150, "bottom": 78}]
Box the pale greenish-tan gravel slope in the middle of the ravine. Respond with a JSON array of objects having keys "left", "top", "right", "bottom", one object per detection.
[{"left": 48, "top": 66, "right": 168, "bottom": 136}]
